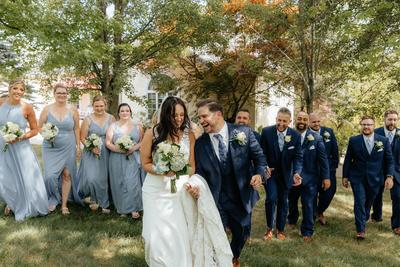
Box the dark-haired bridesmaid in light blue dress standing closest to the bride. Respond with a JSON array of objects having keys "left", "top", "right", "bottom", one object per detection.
[{"left": 106, "top": 103, "right": 143, "bottom": 219}]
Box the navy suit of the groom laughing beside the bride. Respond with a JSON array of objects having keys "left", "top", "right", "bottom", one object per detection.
[{"left": 195, "top": 123, "right": 266, "bottom": 258}]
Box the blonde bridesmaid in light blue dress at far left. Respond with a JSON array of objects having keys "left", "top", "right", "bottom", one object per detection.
[{"left": 0, "top": 80, "right": 48, "bottom": 221}]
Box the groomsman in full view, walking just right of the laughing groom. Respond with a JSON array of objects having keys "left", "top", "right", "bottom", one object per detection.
[{"left": 261, "top": 108, "right": 302, "bottom": 240}]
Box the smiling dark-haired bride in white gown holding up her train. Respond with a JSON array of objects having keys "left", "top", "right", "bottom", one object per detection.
[{"left": 141, "top": 96, "right": 232, "bottom": 267}]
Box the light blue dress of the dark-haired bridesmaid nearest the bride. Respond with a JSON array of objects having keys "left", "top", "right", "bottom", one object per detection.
[{"left": 109, "top": 123, "right": 143, "bottom": 214}]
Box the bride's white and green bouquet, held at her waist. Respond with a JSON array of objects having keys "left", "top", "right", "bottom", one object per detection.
[{"left": 153, "top": 141, "right": 190, "bottom": 193}]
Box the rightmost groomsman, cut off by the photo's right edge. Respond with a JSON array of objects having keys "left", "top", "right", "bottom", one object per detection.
[{"left": 371, "top": 110, "right": 400, "bottom": 235}]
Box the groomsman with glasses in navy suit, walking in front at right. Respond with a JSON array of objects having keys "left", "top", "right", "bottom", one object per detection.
[{"left": 342, "top": 116, "right": 394, "bottom": 239}]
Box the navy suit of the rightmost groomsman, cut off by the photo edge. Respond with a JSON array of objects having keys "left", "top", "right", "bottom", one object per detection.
[{"left": 371, "top": 127, "right": 400, "bottom": 229}]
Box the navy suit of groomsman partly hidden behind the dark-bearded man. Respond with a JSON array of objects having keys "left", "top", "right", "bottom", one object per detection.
[{"left": 316, "top": 127, "right": 339, "bottom": 214}]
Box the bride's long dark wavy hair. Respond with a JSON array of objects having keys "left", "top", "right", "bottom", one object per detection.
[{"left": 151, "top": 96, "right": 190, "bottom": 151}]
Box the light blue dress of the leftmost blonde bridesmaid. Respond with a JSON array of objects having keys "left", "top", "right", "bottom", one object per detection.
[{"left": 0, "top": 102, "right": 48, "bottom": 221}]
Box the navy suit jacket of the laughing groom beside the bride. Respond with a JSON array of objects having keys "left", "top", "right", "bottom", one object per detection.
[{"left": 195, "top": 123, "right": 266, "bottom": 213}]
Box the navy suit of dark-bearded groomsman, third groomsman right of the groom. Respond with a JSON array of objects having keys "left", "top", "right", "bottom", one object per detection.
[{"left": 288, "top": 130, "right": 330, "bottom": 236}]
